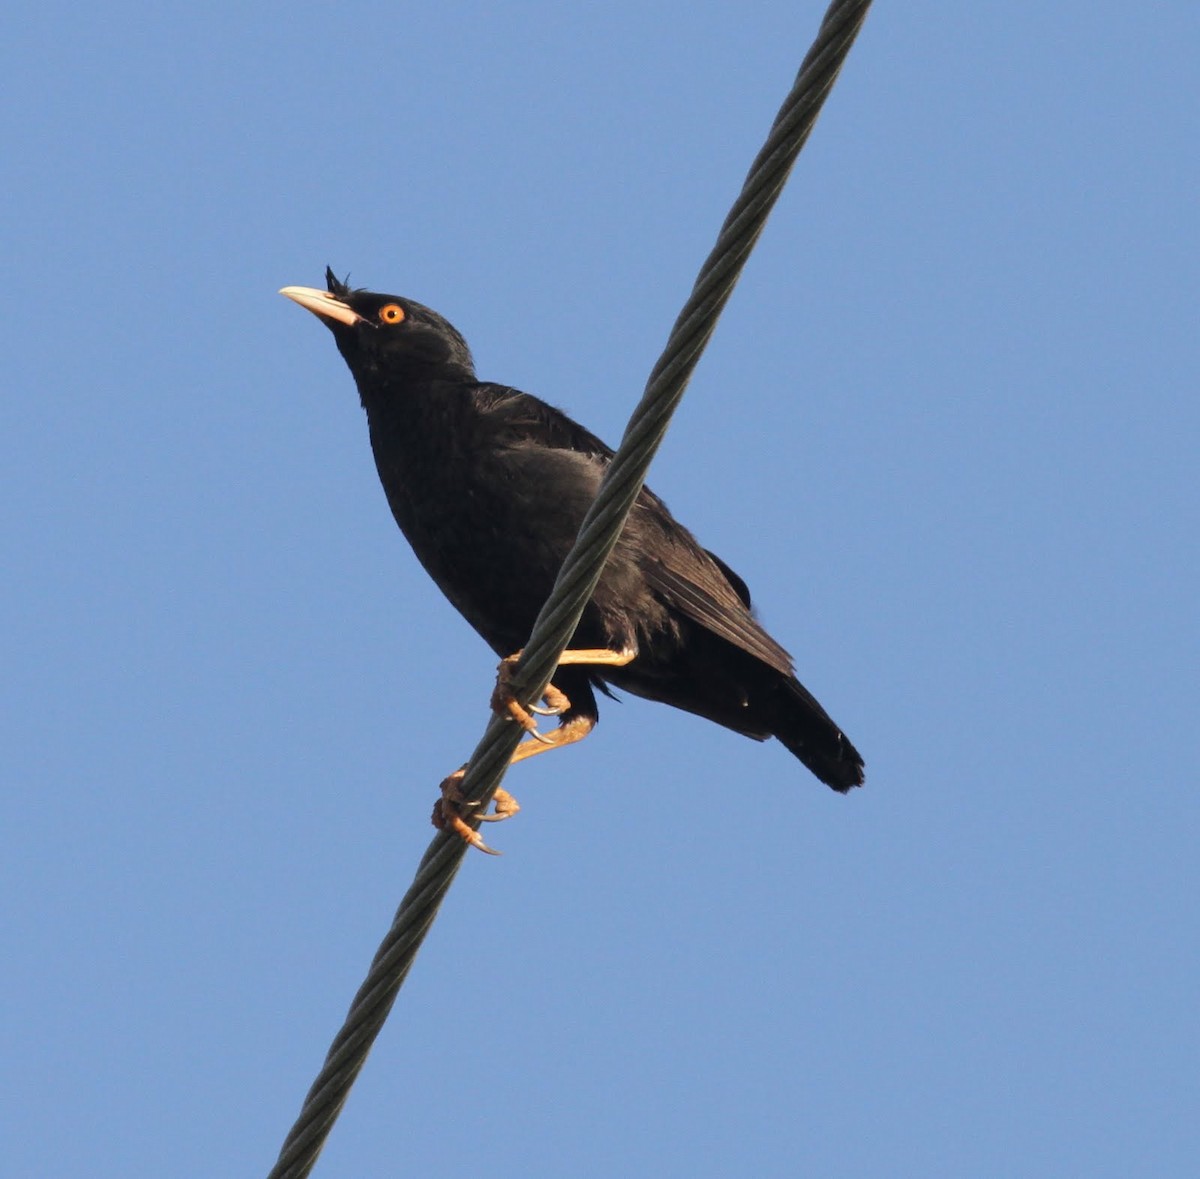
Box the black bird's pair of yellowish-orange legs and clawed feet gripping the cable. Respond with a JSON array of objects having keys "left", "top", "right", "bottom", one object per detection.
[{"left": 433, "top": 647, "right": 636, "bottom": 856}]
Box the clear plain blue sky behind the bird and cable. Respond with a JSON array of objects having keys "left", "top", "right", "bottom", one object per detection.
[{"left": 0, "top": 0, "right": 1200, "bottom": 1179}]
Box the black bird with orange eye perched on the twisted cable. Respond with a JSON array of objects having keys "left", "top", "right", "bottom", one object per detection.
[{"left": 280, "top": 267, "right": 864, "bottom": 851}]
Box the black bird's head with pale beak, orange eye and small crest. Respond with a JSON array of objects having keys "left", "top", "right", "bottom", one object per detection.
[{"left": 280, "top": 267, "right": 475, "bottom": 393}]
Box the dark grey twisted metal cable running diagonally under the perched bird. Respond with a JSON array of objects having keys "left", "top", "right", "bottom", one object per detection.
[{"left": 269, "top": 0, "right": 871, "bottom": 1179}]
